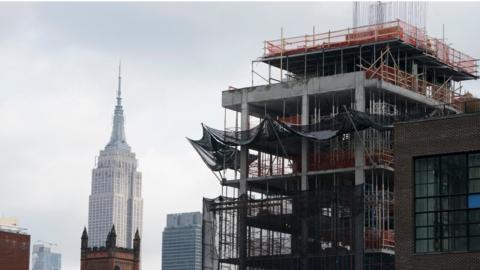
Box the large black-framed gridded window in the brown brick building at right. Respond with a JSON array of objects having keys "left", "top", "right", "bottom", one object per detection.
[{"left": 414, "top": 153, "right": 480, "bottom": 253}]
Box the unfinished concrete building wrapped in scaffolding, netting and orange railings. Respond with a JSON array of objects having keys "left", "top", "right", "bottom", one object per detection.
[{"left": 190, "top": 3, "right": 477, "bottom": 270}]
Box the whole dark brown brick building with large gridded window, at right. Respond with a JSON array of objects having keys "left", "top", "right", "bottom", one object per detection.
[{"left": 394, "top": 113, "right": 480, "bottom": 270}]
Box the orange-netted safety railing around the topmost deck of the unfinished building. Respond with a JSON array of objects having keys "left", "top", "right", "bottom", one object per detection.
[{"left": 264, "top": 20, "right": 477, "bottom": 75}]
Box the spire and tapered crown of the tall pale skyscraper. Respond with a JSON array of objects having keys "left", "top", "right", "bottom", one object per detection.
[{"left": 107, "top": 62, "right": 130, "bottom": 150}]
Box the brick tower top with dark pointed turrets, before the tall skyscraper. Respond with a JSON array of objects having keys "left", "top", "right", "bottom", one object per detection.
[{"left": 80, "top": 226, "right": 140, "bottom": 270}]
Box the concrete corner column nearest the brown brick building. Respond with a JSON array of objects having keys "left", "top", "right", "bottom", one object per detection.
[{"left": 353, "top": 72, "right": 365, "bottom": 270}]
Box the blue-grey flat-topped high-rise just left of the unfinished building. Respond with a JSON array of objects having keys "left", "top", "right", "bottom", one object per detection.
[{"left": 162, "top": 212, "right": 202, "bottom": 270}]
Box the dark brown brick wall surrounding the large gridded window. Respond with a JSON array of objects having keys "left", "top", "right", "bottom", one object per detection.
[{"left": 394, "top": 114, "right": 480, "bottom": 270}]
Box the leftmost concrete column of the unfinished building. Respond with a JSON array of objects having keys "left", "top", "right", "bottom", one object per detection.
[{"left": 237, "top": 89, "right": 250, "bottom": 270}]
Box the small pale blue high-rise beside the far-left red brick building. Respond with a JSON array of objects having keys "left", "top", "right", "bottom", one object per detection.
[{"left": 32, "top": 243, "right": 62, "bottom": 270}]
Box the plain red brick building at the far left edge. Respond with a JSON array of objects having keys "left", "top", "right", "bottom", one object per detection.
[{"left": 0, "top": 228, "right": 30, "bottom": 270}]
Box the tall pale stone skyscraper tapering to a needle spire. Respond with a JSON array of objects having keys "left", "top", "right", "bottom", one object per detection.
[{"left": 88, "top": 67, "right": 143, "bottom": 248}]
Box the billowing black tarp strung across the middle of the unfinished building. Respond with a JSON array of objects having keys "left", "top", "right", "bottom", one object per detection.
[{"left": 188, "top": 110, "right": 393, "bottom": 171}]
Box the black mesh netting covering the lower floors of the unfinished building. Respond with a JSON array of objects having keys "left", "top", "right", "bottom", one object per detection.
[{"left": 204, "top": 186, "right": 361, "bottom": 269}]
